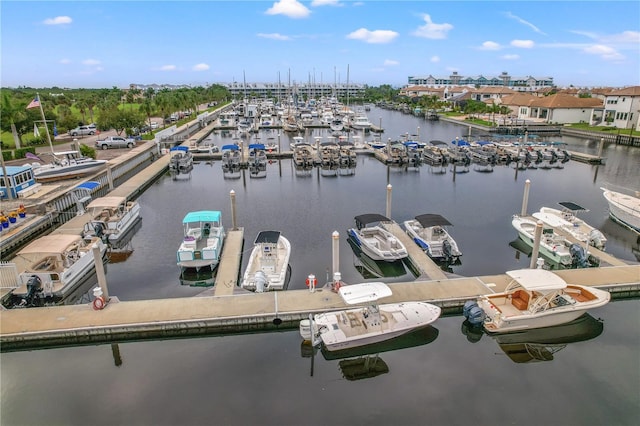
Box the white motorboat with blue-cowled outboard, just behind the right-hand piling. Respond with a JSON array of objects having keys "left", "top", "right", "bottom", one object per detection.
[{"left": 511, "top": 215, "right": 573, "bottom": 267}]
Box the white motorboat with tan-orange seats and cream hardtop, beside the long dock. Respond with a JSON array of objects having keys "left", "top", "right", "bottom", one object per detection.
[{"left": 463, "top": 269, "right": 611, "bottom": 333}]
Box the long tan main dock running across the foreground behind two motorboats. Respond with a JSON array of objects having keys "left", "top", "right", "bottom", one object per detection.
[{"left": 0, "top": 265, "right": 640, "bottom": 351}]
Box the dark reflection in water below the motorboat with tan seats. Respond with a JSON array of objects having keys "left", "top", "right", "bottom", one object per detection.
[{"left": 462, "top": 314, "right": 604, "bottom": 364}]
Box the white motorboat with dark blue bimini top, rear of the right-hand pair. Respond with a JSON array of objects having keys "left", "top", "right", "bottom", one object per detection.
[{"left": 532, "top": 201, "right": 607, "bottom": 250}]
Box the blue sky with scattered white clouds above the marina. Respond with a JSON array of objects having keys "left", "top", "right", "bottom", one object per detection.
[{"left": 0, "top": 0, "right": 640, "bottom": 88}]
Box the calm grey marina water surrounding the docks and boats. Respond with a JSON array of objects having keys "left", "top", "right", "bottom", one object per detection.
[{"left": 0, "top": 108, "right": 640, "bottom": 425}]
